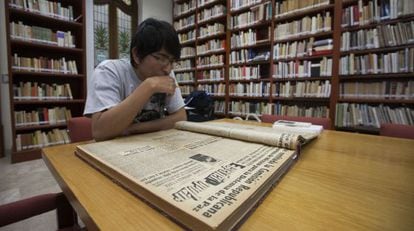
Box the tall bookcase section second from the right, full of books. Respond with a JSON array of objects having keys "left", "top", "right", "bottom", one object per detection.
[{"left": 271, "top": 0, "right": 336, "bottom": 120}]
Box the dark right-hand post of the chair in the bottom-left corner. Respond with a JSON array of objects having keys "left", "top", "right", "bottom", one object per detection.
[{"left": 56, "top": 193, "right": 78, "bottom": 229}]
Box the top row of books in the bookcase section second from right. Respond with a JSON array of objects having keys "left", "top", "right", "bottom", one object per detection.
[{"left": 275, "top": 0, "right": 329, "bottom": 18}]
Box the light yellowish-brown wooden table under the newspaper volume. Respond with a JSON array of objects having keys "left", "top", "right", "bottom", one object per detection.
[{"left": 43, "top": 122, "right": 414, "bottom": 230}]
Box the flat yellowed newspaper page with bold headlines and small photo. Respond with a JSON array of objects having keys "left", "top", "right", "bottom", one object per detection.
[{"left": 78, "top": 129, "right": 296, "bottom": 230}]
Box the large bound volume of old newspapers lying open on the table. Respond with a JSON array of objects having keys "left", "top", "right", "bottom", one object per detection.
[{"left": 76, "top": 122, "right": 311, "bottom": 230}]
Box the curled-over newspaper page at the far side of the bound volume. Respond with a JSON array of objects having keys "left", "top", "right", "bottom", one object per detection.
[{"left": 175, "top": 121, "right": 310, "bottom": 149}]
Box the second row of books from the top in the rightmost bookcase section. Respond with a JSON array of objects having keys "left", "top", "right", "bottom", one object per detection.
[{"left": 341, "top": 21, "right": 414, "bottom": 51}]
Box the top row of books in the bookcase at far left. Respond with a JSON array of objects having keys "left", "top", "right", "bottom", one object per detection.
[{"left": 9, "top": 0, "right": 74, "bottom": 21}]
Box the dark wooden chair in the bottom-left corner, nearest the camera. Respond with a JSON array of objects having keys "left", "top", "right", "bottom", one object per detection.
[{"left": 0, "top": 192, "right": 80, "bottom": 230}]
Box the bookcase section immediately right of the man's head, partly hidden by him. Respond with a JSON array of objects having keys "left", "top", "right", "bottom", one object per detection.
[{"left": 173, "top": 0, "right": 228, "bottom": 115}]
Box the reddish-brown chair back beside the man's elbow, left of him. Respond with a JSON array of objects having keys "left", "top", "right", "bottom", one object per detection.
[{"left": 68, "top": 117, "right": 93, "bottom": 143}]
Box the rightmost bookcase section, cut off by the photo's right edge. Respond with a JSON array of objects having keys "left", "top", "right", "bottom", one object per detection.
[{"left": 335, "top": 0, "right": 414, "bottom": 133}]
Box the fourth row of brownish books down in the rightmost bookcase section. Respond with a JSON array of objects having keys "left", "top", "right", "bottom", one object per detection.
[{"left": 339, "top": 80, "right": 414, "bottom": 99}]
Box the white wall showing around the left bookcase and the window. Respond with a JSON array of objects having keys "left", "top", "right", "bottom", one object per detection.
[{"left": 0, "top": 0, "right": 172, "bottom": 153}]
